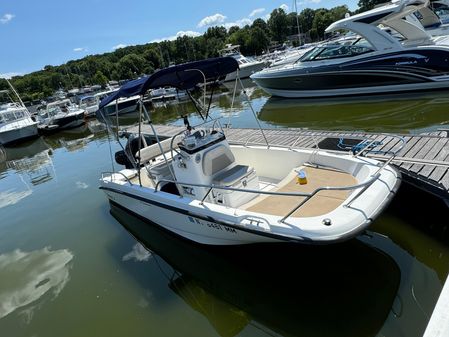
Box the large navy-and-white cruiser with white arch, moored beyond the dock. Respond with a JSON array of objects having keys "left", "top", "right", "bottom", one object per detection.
[{"left": 251, "top": 0, "right": 449, "bottom": 98}]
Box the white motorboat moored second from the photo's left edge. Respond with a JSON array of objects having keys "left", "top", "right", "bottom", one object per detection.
[{"left": 37, "top": 98, "right": 85, "bottom": 132}]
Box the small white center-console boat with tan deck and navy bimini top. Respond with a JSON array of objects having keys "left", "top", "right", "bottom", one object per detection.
[{"left": 100, "top": 57, "right": 400, "bottom": 245}]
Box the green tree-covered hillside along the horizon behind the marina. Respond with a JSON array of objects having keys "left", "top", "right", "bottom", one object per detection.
[{"left": 0, "top": 0, "right": 379, "bottom": 101}]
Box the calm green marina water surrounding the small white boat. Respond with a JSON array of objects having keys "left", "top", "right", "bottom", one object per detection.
[{"left": 0, "top": 82, "right": 449, "bottom": 337}]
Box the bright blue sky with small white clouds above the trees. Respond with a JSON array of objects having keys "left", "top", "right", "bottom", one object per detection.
[{"left": 0, "top": 0, "right": 358, "bottom": 77}]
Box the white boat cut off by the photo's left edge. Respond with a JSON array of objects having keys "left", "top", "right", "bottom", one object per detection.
[{"left": 0, "top": 80, "right": 38, "bottom": 145}]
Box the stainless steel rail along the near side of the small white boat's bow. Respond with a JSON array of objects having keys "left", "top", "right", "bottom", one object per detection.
[{"left": 154, "top": 168, "right": 382, "bottom": 223}]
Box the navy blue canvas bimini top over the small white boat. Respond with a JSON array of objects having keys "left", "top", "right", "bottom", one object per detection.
[{"left": 99, "top": 57, "right": 239, "bottom": 109}]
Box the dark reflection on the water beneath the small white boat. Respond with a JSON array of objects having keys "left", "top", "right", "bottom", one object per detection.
[{"left": 111, "top": 202, "right": 401, "bottom": 337}]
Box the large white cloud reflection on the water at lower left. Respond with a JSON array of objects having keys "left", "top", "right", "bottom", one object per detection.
[{"left": 0, "top": 247, "right": 73, "bottom": 319}]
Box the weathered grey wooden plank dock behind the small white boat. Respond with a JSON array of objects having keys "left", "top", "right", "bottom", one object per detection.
[{"left": 124, "top": 125, "right": 449, "bottom": 202}]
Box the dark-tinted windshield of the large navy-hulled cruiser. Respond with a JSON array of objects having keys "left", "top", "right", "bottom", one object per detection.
[{"left": 298, "top": 38, "right": 374, "bottom": 62}]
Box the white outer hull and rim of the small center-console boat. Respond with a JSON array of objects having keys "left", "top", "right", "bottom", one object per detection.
[{"left": 100, "top": 149, "right": 401, "bottom": 245}]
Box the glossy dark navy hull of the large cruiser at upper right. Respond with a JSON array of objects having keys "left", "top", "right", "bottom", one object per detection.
[{"left": 251, "top": 50, "right": 449, "bottom": 98}]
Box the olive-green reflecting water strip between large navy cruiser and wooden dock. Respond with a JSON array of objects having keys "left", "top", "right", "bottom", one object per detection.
[{"left": 259, "top": 92, "right": 449, "bottom": 132}]
